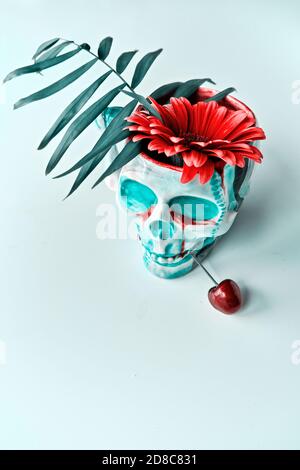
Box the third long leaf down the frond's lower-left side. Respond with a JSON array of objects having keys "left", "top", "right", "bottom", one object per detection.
[{"left": 38, "top": 70, "right": 112, "bottom": 150}]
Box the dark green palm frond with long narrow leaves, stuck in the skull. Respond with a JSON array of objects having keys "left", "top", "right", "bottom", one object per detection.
[{"left": 4, "top": 37, "right": 234, "bottom": 195}]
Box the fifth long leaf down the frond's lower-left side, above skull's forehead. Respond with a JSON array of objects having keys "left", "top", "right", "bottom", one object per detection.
[{"left": 55, "top": 100, "right": 137, "bottom": 178}]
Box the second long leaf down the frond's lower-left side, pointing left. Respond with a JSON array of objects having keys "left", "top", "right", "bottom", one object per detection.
[{"left": 14, "top": 59, "right": 97, "bottom": 109}]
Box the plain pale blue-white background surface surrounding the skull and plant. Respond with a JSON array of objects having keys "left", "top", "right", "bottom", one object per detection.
[{"left": 0, "top": 0, "right": 300, "bottom": 449}]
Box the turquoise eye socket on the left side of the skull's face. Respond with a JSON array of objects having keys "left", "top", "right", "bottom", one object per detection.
[{"left": 120, "top": 178, "right": 157, "bottom": 213}]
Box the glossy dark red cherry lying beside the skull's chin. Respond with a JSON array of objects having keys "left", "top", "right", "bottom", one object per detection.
[{"left": 208, "top": 279, "right": 242, "bottom": 315}]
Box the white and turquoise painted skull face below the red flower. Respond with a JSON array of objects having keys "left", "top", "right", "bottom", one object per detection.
[{"left": 117, "top": 156, "right": 253, "bottom": 279}]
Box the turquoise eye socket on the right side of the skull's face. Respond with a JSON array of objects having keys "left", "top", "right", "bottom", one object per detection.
[{"left": 169, "top": 196, "right": 219, "bottom": 223}]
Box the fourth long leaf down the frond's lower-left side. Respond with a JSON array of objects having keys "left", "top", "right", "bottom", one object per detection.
[{"left": 46, "top": 84, "right": 125, "bottom": 174}]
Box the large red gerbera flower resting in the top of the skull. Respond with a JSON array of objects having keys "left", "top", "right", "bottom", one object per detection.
[{"left": 127, "top": 98, "right": 265, "bottom": 184}]
